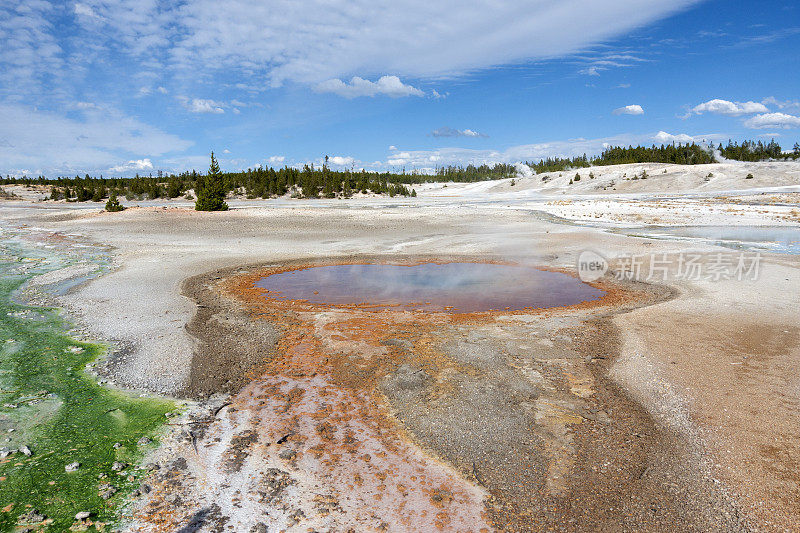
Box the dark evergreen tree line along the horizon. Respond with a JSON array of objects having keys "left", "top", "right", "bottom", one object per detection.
[{"left": 0, "top": 140, "right": 800, "bottom": 202}]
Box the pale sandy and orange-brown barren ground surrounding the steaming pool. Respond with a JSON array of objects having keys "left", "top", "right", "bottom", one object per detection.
[{"left": 0, "top": 163, "right": 800, "bottom": 531}]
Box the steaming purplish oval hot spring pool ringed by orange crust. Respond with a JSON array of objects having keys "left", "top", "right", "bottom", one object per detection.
[{"left": 256, "top": 263, "right": 605, "bottom": 313}]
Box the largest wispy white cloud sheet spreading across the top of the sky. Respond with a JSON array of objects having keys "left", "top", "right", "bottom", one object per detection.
[{"left": 53, "top": 0, "right": 698, "bottom": 86}]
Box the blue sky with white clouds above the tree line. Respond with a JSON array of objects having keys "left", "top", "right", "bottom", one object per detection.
[{"left": 0, "top": 0, "right": 800, "bottom": 177}]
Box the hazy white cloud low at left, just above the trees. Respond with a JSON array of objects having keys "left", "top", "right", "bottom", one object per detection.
[{"left": 0, "top": 104, "right": 192, "bottom": 176}]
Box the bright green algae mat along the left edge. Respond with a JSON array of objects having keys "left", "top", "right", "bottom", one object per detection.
[{"left": 0, "top": 229, "right": 175, "bottom": 531}]
